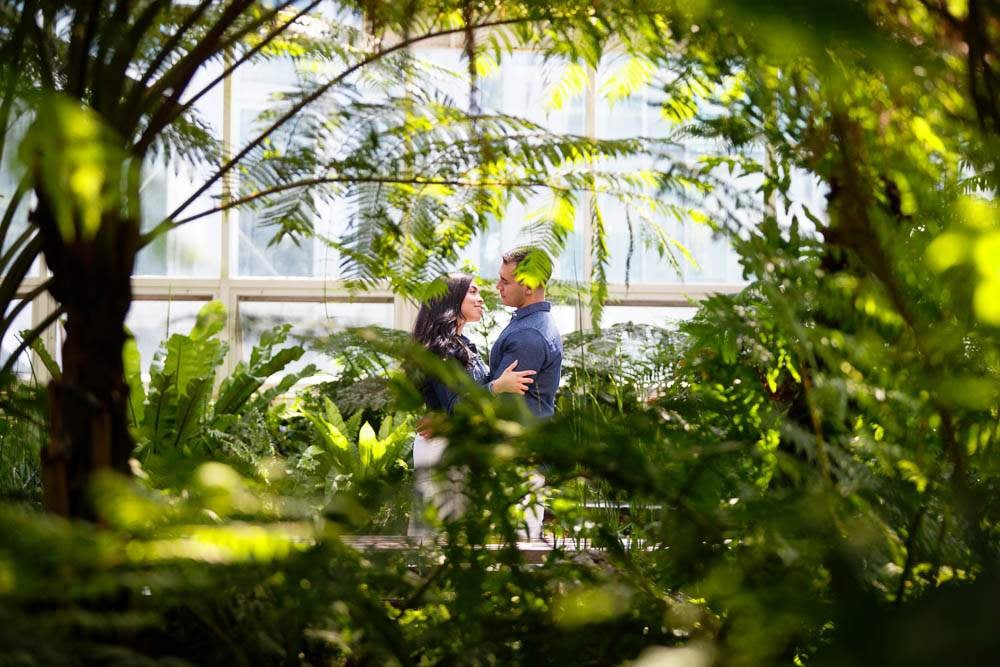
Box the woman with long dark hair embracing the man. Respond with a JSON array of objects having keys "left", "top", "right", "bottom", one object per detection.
[{"left": 409, "top": 273, "right": 535, "bottom": 535}]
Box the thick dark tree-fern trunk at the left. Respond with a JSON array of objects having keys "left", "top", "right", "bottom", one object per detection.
[{"left": 32, "top": 191, "right": 139, "bottom": 519}]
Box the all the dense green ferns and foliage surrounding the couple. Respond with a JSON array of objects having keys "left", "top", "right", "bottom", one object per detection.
[{"left": 0, "top": 0, "right": 1000, "bottom": 665}]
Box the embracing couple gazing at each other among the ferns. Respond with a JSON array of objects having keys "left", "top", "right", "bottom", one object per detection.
[{"left": 410, "top": 247, "right": 562, "bottom": 539}]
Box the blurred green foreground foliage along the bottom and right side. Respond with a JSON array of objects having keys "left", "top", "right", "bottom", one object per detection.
[{"left": 0, "top": 0, "right": 1000, "bottom": 665}]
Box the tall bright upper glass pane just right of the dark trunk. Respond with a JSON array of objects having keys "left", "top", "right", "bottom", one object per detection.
[{"left": 135, "top": 63, "right": 223, "bottom": 277}]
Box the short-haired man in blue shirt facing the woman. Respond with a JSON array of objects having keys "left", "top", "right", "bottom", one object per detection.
[{"left": 488, "top": 247, "right": 562, "bottom": 540}]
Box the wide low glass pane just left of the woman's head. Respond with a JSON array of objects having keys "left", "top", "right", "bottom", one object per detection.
[{"left": 239, "top": 301, "right": 394, "bottom": 374}]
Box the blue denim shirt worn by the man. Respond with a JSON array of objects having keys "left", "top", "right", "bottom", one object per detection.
[{"left": 489, "top": 301, "right": 562, "bottom": 417}]
